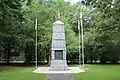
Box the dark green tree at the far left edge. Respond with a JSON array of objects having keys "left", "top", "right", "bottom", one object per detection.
[{"left": 0, "top": 0, "right": 23, "bottom": 63}]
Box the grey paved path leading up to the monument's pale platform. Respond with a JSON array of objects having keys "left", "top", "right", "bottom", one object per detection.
[{"left": 47, "top": 73, "right": 74, "bottom": 80}]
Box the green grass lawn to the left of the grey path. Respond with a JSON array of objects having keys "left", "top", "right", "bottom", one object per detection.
[{"left": 0, "top": 67, "right": 47, "bottom": 80}]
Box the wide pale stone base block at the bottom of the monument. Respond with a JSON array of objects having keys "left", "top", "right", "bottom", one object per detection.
[{"left": 50, "top": 60, "right": 68, "bottom": 71}]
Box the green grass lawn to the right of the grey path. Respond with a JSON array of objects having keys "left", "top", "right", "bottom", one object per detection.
[{"left": 73, "top": 65, "right": 120, "bottom": 80}]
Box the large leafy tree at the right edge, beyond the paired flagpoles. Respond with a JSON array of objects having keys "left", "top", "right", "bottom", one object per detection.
[{"left": 86, "top": 0, "right": 120, "bottom": 63}]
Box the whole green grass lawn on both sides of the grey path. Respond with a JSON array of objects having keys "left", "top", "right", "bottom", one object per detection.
[{"left": 0, "top": 65, "right": 120, "bottom": 80}]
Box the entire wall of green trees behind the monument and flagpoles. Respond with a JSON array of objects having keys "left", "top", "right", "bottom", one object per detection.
[{"left": 0, "top": 0, "right": 120, "bottom": 63}]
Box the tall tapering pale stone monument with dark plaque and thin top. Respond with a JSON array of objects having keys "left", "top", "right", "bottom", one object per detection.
[{"left": 50, "top": 10, "right": 68, "bottom": 71}]
